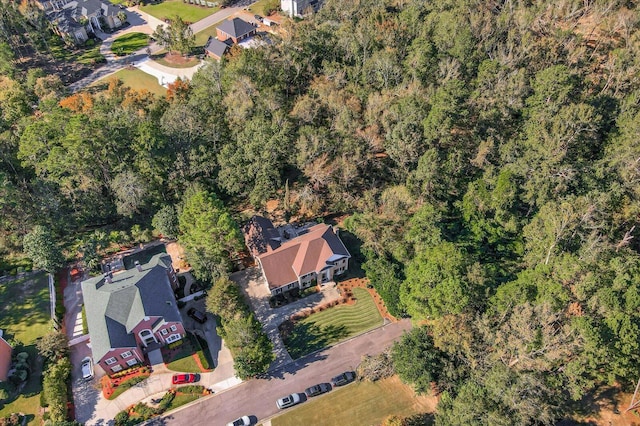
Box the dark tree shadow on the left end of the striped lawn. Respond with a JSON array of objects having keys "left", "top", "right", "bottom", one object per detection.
[{"left": 279, "top": 321, "right": 349, "bottom": 359}]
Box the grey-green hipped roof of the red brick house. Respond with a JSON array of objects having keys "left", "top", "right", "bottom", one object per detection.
[{"left": 82, "top": 253, "right": 182, "bottom": 362}]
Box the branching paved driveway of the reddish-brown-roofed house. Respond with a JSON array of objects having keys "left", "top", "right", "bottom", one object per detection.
[{"left": 229, "top": 267, "right": 340, "bottom": 370}]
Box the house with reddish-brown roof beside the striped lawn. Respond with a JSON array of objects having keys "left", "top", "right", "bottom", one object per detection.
[{"left": 244, "top": 216, "right": 351, "bottom": 295}]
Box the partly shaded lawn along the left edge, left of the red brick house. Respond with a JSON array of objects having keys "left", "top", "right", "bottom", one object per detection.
[{"left": 0, "top": 273, "right": 51, "bottom": 424}]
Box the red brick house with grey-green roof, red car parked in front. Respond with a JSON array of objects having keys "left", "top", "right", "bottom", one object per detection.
[{"left": 82, "top": 253, "right": 185, "bottom": 375}]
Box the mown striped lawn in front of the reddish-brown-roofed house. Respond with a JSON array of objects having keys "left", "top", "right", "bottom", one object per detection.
[{"left": 283, "top": 288, "right": 382, "bottom": 359}]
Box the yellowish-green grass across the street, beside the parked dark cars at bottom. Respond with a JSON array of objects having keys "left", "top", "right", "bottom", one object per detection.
[{"left": 271, "top": 376, "right": 436, "bottom": 426}]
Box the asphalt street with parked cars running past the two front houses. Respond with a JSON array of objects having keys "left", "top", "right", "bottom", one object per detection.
[{"left": 156, "top": 320, "right": 411, "bottom": 426}]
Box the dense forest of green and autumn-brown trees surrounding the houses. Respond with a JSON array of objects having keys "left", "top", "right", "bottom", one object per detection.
[{"left": 0, "top": 0, "right": 640, "bottom": 425}]
